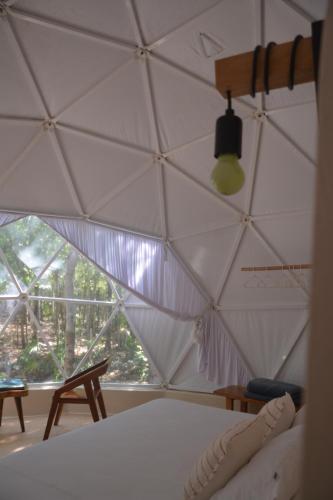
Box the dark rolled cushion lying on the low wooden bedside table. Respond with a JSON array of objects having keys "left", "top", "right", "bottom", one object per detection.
[{"left": 245, "top": 378, "right": 303, "bottom": 405}]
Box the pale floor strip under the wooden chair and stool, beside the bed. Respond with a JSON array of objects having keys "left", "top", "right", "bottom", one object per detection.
[{"left": 0, "top": 414, "right": 92, "bottom": 458}]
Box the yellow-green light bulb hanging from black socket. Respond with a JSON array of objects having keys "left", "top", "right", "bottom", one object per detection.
[{"left": 211, "top": 154, "right": 245, "bottom": 195}]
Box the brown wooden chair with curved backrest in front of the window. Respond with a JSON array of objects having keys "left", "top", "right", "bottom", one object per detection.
[{"left": 43, "top": 359, "right": 108, "bottom": 441}]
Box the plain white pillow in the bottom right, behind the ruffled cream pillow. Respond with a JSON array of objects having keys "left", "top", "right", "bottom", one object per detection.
[{"left": 211, "top": 425, "right": 304, "bottom": 500}]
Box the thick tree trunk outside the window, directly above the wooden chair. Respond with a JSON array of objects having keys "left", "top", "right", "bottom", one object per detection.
[{"left": 64, "top": 250, "right": 79, "bottom": 377}]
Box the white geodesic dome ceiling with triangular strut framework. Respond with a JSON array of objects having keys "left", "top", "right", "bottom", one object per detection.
[{"left": 0, "top": 0, "right": 326, "bottom": 388}]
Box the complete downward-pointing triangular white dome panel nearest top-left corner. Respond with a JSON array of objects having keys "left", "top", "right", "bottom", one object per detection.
[{"left": 10, "top": 14, "right": 130, "bottom": 116}]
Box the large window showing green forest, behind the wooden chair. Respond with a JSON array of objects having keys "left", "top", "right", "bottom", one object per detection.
[{"left": 0, "top": 216, "right": 156, "bottom": 383}]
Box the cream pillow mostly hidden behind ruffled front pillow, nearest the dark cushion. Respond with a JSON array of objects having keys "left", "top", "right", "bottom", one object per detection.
[{"left": 258, "top": 393, "right": 295, "bottom": 440}]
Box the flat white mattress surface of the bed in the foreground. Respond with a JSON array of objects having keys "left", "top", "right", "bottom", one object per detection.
[{"left": 0, "top": 399, "right": 253, "bottom": 500}]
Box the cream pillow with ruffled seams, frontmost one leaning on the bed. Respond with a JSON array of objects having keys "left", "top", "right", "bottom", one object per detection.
[{"left": 184, "top": 416, "right": 266, "bottom": 500}]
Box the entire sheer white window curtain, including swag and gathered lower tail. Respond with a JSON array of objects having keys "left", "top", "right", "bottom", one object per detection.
[{"left": 0, "top": 213, "right": 252, "bottom": 386}]
